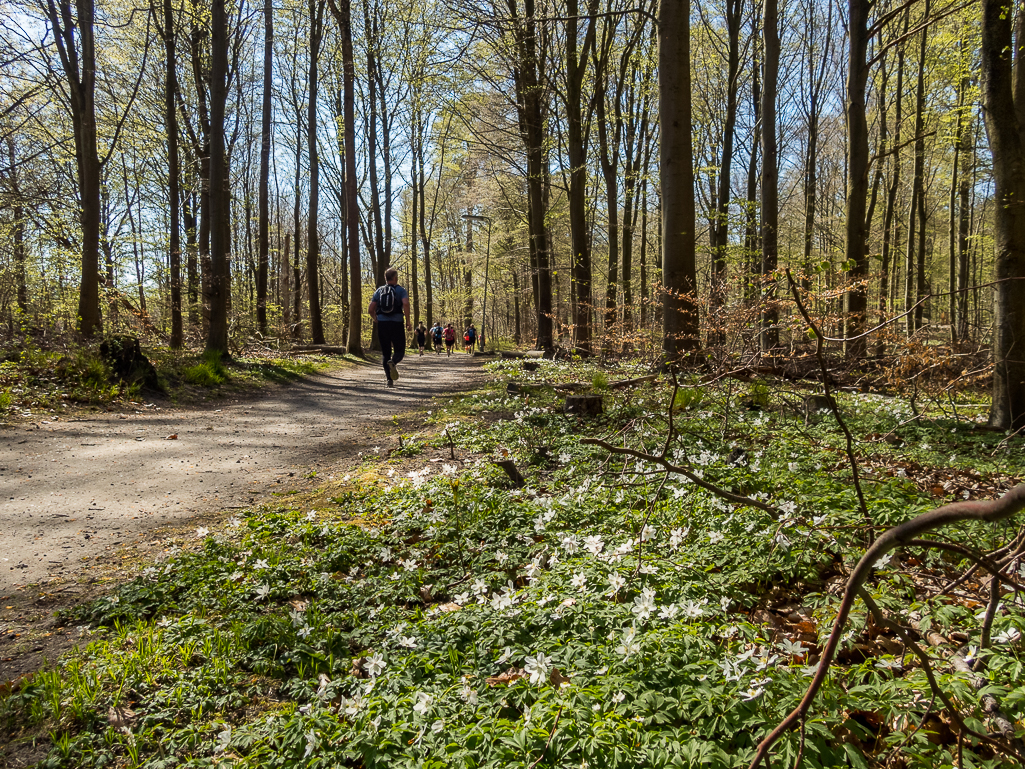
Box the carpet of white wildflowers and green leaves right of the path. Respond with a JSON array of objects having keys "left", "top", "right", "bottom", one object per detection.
[{"left": 0, "top": 361, "right": 1025, "bottom": 769}]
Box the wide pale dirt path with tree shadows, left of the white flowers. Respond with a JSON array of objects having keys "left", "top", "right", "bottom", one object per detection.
[{"left": 0, "top": 353, "right": 481, "bottom": 682}]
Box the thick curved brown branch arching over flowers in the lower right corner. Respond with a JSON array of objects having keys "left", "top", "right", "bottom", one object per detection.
[{"left": 748, "top": 484, "right": 1025, "bottom": 769}]
